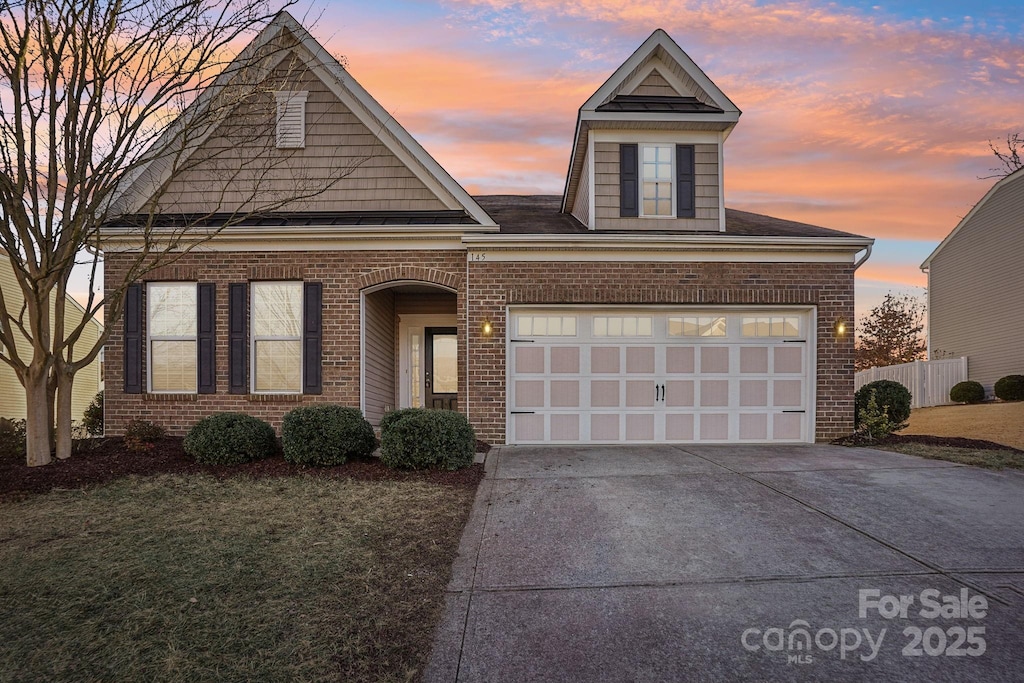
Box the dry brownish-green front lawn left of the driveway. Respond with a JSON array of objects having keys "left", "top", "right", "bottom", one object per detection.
[{"left": 0, "top": 473, "right": 475, "bottom": 681}]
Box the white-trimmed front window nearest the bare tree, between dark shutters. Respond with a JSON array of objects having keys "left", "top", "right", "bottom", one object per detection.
[{"left": 145, "top": 283, "right": 199, "bottom": 393}]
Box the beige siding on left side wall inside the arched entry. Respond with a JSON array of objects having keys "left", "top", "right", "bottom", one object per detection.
[{"left": 364, "top": 290, "right": 397, "bottom": 425}]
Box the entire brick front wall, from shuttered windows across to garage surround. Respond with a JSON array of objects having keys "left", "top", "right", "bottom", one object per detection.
[{"left": 104, "top": 251, "right": 853, "bottom": 443}]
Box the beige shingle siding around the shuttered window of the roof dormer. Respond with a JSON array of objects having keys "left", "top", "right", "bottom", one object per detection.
[{"left": 594, "top": 142, "right": 720, "bottom": 230}]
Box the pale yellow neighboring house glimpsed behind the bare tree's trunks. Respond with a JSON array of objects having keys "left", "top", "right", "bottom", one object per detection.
[{"left": 0, "top": 251, "right": 103, "bottom": 422}]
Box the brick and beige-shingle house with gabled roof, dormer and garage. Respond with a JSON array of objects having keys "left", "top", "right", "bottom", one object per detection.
[{"left": 104, "top": 13, "right": 872, "bottom": 443}]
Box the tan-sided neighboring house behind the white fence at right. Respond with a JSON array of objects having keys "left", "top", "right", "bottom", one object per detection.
[{"left": 921, "top": 169, "right": 1024, "bottom": 394}]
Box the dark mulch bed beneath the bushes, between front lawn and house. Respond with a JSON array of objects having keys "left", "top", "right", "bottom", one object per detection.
[{"left": 0, "top": 437, "right": 489, "bottom": 498}]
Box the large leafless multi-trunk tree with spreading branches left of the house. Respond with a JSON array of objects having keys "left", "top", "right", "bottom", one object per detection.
[{"left": 0, "top": 0, "right": 364, "bottom": 465}]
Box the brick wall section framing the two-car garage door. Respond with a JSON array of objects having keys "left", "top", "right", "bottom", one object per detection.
[{"left": 468, "top": 261, "right": 853, "bottom": 443}]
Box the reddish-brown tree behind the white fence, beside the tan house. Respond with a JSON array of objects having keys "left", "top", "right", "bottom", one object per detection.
[{"left": 854, "top": 292, "right": 928, "bottom": 371}]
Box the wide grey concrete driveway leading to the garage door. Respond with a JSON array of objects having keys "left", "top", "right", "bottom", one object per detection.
[{"left": 425, "top": 445, "right": 1024, "bottom": 683}]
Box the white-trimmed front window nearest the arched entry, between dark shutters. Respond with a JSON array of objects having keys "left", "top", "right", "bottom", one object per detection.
[{"left": 250, "top": 282, "right": 302, "bottom": 393}]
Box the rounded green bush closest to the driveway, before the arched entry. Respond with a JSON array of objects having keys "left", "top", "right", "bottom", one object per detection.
[{"left": 381, "top": 409, "right": 476, "bottom": 470}]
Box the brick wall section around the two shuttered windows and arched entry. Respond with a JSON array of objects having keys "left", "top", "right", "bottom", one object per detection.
[{"left": 104, "top": 251, "right": 466, "bottom": 435}]
